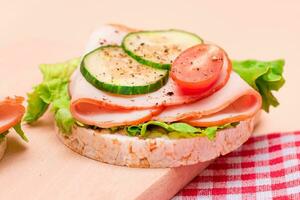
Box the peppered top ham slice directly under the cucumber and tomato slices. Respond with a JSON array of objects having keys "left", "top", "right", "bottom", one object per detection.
[{"left": 69, "top": 25, "right": 231, "bottom": 109}]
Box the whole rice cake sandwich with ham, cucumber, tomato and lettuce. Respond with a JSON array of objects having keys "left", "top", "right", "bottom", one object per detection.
[{"left": 24, "top": 24, "right": 285, "bottom": 168}]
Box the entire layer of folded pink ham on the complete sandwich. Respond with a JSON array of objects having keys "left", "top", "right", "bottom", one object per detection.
[{"left": 69, "top": 25, "right": 261, "bottom": 128}]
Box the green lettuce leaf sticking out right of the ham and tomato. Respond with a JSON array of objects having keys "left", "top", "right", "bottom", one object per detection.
[{"left": 232, "top": 60, "right": 285, "bottom": 112}]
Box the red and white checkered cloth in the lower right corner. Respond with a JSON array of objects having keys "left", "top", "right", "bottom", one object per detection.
[{"left": 173, "top": 132, "right": 300, "bottom": 200}]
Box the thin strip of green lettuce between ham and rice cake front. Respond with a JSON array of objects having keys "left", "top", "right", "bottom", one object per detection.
[{"left": 125, "top": 121, "right": 239, "bottom": 140}]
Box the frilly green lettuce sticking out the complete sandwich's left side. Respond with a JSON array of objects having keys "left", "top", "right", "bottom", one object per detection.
[{"left": 24, "top": 58, "right": 80, "bottom": 134}]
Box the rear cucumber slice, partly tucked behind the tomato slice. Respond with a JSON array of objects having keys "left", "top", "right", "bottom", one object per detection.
[{"left": 122, "top": 30, "right": 203, "bottom": 69}]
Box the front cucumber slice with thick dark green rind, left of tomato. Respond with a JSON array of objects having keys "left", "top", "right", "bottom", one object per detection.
[{"left": 80, "top": 46, "right": 169, "bottom": 95}]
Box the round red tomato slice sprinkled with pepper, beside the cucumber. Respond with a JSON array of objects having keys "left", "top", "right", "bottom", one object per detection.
[{"left": 170, "top": 44, "right": 229, "bottom": 92}]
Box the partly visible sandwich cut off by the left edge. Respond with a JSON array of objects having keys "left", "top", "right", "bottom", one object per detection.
[{"left": 0, "top": 97, "right": 28, "bottom": 160}]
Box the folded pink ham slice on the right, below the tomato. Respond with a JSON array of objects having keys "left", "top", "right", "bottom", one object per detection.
[{"left": 154, "top": 72, "right": 261, "bottom": 126}]
